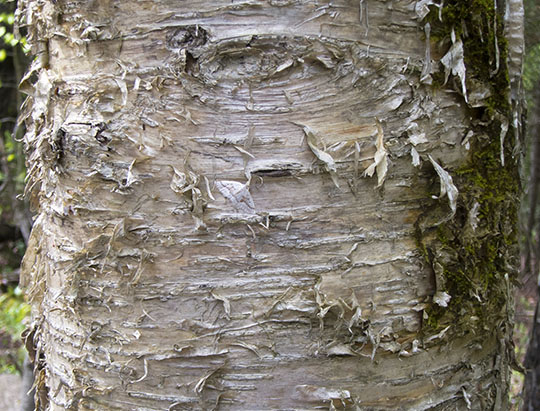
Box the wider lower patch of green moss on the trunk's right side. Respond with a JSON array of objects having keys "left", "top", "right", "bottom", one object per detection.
[{"left": 425, "top": 139, "right": 520, "bottom": 334}]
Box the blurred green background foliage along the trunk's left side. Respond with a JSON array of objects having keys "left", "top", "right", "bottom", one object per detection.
[{"left": 0, "top": 0, "right": 30, "bottom": 373}]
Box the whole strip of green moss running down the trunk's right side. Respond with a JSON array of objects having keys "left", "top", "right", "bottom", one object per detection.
[{"left": 417, "top": 0, "right": 520, "bottom": 335}]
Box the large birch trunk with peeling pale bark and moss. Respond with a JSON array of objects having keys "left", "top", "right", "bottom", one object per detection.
[{"left": 21, "top": 0, "right": 519, "bottom": 410}]
